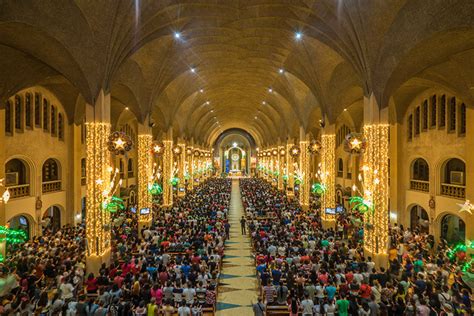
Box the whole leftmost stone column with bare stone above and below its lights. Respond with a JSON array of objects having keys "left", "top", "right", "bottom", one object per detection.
[{"left": 86, "top": 91, "right": 111, "bottom": 273}]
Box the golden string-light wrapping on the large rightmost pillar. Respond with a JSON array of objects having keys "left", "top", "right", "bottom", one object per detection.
[{"left": 362, "top": 124, "right": 389, "bottom": 255}]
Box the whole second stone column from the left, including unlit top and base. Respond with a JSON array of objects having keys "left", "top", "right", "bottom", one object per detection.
[{"left": 137, "top": 120, "right": 153, "bottom": 233}]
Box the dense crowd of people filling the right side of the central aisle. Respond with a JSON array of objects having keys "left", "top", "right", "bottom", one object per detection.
[{"left": 240, "top": 179, "right": 472, "bottom": 316}]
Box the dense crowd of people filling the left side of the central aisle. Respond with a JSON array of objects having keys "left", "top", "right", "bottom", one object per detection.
[{"left": 0, "top": 179, "right": 231, "bottom": 316}]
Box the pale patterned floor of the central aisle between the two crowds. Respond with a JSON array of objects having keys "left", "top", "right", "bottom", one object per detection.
[{"left": 217, "top": 179, "right": 258, "bottom": 316}]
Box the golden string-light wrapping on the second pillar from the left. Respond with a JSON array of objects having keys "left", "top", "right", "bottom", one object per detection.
[{"left": 137, "top": 134, "right": 153, "bottom": 222}]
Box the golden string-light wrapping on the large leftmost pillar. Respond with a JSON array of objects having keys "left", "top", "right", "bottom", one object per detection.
[{"left": 85, "top": 122, "right": 111, "bottom": 257}]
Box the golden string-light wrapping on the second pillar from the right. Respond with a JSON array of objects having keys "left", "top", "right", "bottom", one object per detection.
[{"left": 319, "top": 134, "right": 336, "bottom": 221}]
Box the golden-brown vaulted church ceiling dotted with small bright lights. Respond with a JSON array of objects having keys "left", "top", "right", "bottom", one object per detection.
[{"left": 0, "top": 0, "right": 474, "bottom": 144}]
